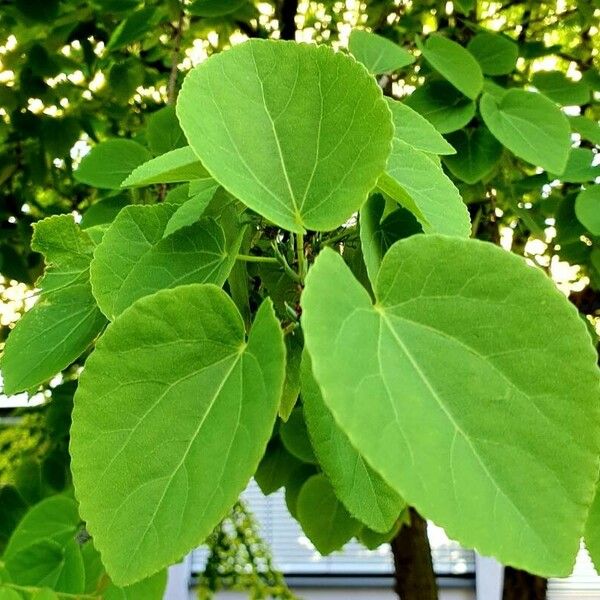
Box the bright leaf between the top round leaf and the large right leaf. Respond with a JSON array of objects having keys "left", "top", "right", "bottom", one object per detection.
[{"left": 377, "top": 140, "right": 471, "bottom": 237}]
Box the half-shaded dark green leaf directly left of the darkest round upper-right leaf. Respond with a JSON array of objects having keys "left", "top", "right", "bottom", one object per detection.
[{"left": 404, "top": 81, "right": 476, "bottom": 133}]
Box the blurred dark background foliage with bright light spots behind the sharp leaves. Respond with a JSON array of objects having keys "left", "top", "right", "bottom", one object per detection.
[{"left": 0, "top": 0, "right": 600, "bottom": 597}]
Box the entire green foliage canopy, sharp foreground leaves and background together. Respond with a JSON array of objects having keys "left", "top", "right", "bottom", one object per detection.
[{"left": 0, "top": 0, "right": 600, "bottom": 599}]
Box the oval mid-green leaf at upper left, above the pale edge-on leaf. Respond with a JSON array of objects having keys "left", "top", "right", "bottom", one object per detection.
[{"left": 73, "top": 139, "right": 152, "bottom": 190}]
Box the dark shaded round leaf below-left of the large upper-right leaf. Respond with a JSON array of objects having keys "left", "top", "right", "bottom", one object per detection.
[{"left": 443, "top": 126, "right": 503, "bottom": 184}]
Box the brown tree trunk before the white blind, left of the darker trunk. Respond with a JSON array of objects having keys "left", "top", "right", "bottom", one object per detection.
[{"left": 392, "top": 508, "right": 438, "bottom": 600}]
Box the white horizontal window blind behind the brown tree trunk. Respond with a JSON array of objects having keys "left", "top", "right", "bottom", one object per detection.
[{"left": 192, "top": 481, "right": 475, "bottom": 575}]
